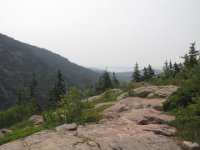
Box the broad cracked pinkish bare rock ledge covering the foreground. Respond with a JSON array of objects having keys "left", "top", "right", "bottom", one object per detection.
[{"left": 0, "top": 86, "right": 181, "bottom": 150}]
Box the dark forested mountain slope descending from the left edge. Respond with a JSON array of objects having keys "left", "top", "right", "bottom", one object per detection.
[{"left": 0, "top": 34, "right": 99, "bottom": 109}]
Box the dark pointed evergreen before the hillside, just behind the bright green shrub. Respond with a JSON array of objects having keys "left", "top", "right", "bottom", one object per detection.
[{"left": 49, "top": 70, "right": 66, "bottom": 107}]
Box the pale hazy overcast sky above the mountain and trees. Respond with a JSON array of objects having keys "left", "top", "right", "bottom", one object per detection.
[{"left": 0, "top": 0, "right": 200, "bottom": 71}]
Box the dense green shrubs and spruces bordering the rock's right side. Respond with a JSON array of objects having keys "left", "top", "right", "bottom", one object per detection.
[{"left": 154, "top": 43, "right": 200, "bottom": 144}]
